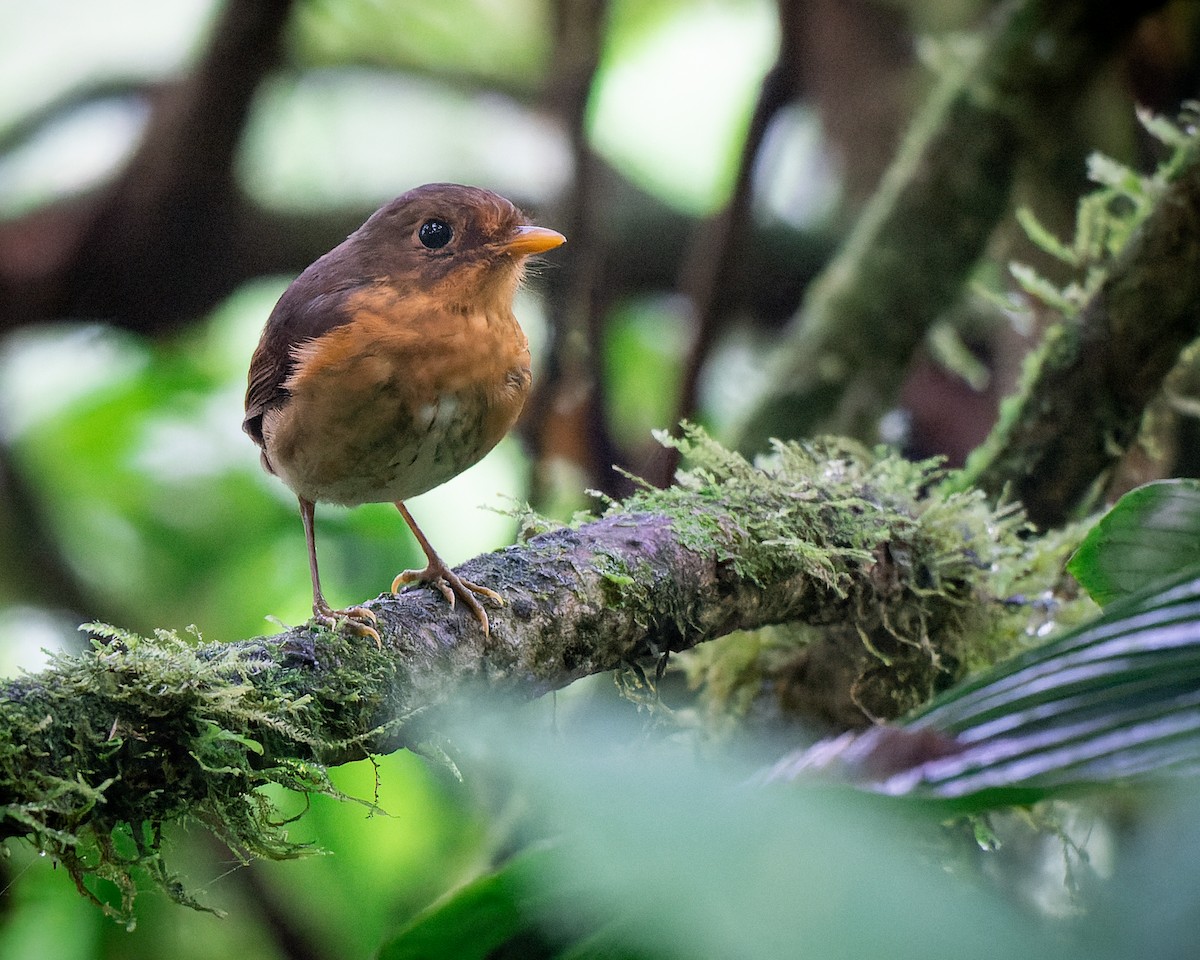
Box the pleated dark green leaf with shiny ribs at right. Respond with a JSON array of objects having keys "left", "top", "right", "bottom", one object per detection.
[{"left": 801, "top": 569, "right": 1200, "bottom": 810}]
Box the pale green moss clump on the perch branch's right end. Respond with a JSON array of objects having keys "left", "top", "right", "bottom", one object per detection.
[{"left": 667, "top": 427, "right": 1099, "bottom": 727}]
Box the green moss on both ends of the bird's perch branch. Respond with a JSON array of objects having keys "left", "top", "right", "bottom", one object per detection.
[{"left": 0, "top": 426, "right": 1099, "bottom": 919}]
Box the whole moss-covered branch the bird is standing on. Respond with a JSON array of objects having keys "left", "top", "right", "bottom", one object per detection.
[{"left": 0, "top": 431, "right": 1051, "bottom": 913}]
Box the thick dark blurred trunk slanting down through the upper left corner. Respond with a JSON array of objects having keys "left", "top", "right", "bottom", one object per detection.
[{"left": 0, "top": 0, "right": 292, "bottom": 330}]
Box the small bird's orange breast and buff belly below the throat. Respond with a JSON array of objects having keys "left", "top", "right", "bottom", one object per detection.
[{"left": 263, "top": 303, "right": 530, "bottom": 506}]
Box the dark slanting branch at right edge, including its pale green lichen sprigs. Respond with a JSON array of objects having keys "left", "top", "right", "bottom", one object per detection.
[{"left": 958, "top": 104, "right": 1200, "bottom": 527}]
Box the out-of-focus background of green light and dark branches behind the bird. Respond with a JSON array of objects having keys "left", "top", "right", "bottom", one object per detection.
[{"left": 0, "top": 0, "right": 1196, "bottom": 960}]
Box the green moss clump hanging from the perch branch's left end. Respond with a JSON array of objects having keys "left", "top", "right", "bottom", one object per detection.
[{"left": 0, "top": 624, "right": 369, "bottom": 925}]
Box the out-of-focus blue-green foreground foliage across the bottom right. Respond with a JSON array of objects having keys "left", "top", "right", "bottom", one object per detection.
[{"left": 382, "top": 716, "right": 1198, "bottom": 960}]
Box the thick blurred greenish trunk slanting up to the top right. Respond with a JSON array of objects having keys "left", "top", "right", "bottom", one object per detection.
[{"left": 740, "top": 0, "right": 1163, "bottom": 450}]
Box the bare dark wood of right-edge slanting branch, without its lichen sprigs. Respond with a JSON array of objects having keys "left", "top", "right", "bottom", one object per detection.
[{"left": 961, "top": 138, "right": 1200, "bottom": 527}]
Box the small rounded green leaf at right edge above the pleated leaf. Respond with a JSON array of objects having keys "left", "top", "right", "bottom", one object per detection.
[{"left": 1067, "top": 480, "right": 1200, "bottom": 606}]
